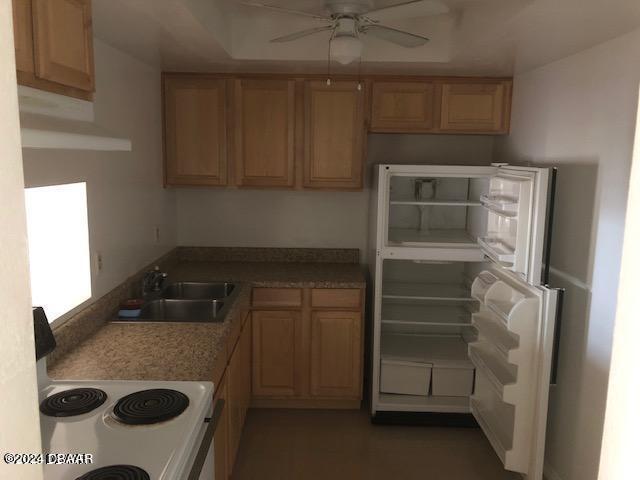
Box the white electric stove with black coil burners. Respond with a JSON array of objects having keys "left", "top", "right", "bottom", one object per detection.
[{"left": 37, "top": 308, "right": 222, "bottom": 480}]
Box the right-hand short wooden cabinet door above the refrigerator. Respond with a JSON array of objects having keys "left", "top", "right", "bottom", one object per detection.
[{"left": 440, "top": 81, "right": 511, "bottom": 134}]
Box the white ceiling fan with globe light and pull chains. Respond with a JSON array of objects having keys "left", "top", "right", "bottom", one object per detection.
[{"left": 240, "top": 0, "right": 449, "bottom": 65}]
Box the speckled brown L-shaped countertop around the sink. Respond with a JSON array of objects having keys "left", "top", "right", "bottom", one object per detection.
[{"left": 49, "top": 262, "right": 365, "bottom": 381}]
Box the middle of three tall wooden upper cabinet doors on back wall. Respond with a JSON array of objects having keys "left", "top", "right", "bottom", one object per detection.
[{"left": 234, "top": 80, "right": 295, "bottom": 187}]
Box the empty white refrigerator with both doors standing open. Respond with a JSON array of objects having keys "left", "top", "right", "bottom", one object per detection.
[{"left": 370, "top": 164, "right": 562, "bottom": 480}]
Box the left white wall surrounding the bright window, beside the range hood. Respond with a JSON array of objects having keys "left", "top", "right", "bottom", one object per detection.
[{"left": 23, "top": 40, "right": 176, "bottom": 312}]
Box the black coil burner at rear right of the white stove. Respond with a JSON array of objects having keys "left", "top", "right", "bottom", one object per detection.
[{"left": 113, "top": 388, "right": 189, "bottom": 425}]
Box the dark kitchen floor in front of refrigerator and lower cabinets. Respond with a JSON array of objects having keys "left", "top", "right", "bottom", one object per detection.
[{"left": 233, "top": 409, "right": 517, "bottom": 480}]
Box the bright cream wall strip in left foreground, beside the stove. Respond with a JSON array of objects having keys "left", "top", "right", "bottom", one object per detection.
[{"left": 0, "top": 2, "right": 42, "bottom": 480}]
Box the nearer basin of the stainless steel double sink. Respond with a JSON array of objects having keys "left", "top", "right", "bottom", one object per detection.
[{"left": 134, "top": 298, "right": 227, "bottom": 323}]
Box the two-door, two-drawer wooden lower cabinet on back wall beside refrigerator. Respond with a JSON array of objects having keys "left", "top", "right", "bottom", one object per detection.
[{"left": 252, "top": 288, "right": 363, "bottom": 408}]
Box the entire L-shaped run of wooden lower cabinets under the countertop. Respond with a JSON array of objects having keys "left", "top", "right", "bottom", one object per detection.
[{"left": 214, "top": 288, "right": 363, "bottom": 480}]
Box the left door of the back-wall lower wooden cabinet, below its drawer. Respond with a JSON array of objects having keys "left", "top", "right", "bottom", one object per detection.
[{"left": 251, "top": 311, "right": 301, "bottom": 397}]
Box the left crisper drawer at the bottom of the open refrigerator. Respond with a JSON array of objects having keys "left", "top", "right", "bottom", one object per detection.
[{"left": 380, "top": 358, "right": 432, "bottom": 397}]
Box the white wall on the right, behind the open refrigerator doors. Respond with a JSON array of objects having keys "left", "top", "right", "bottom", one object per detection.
[{"left": 496, "top": 30, "right": 640, "bottom": 480}]
